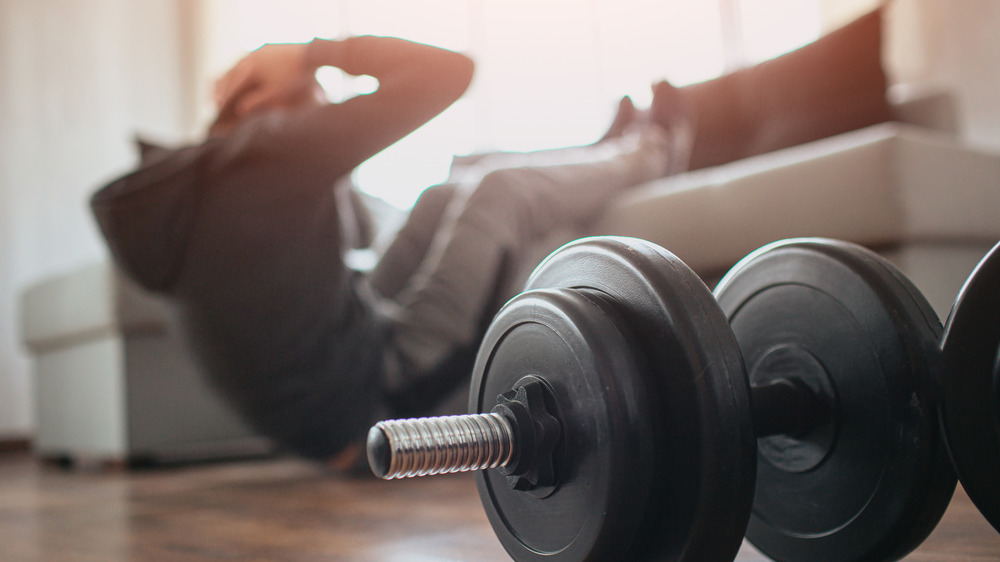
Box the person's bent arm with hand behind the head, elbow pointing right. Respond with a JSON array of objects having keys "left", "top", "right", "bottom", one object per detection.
[{"left": 216, "top": 36, "right": 473, "bottom": 175}]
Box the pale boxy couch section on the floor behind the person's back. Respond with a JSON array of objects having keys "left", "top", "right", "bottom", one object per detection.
[{"left": 21, "top": 262, "right": 273, "bottom": 463}]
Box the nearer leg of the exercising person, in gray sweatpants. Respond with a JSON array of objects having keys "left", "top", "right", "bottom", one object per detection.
[{"left": 385, "top": 127, "right": 672, "bottom": 392}]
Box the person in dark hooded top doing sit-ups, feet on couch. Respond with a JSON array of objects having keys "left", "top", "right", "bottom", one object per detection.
[{"left": 91, "top": 37, "right": 687, "bottom": 459}]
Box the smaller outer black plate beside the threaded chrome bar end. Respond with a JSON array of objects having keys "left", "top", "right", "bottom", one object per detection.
[{"left": 471, "top": 290, "right": 652, "bottom": 560}]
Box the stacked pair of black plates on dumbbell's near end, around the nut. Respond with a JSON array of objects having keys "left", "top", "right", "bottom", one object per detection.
[{"left": 470, "top": 238, "right": 755, "bottom": 560}]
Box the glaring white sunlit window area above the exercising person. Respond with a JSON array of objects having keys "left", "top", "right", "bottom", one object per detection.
[{"left": 193, "top": 0, "right": 823, "bottom": 208}]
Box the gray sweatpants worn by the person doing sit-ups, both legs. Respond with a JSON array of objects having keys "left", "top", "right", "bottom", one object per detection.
[{"left": 371, "top": 129, "right": 671, "bottom": 392}]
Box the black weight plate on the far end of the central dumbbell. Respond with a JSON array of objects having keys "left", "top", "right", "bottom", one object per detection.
[{"left": 715, "top": 239, "right": 955, "bottom": 561}]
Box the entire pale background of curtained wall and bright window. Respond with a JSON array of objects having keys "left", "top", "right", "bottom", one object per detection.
[{"left": 13, "top": 0, "right": 1000, "bottom": 442}]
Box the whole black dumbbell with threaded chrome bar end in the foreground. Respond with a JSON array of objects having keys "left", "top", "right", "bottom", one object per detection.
[{"left": 369, "top": 234, "right": 955, "bottom": 560}]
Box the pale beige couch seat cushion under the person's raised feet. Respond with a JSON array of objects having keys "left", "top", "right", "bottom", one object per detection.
[{"left": 589, "top": 123, "right": 1000, "bottom": 276}]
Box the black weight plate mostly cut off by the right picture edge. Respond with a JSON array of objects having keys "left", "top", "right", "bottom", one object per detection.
[{"left": 941, "top": 244, "right": 1000, "bottom": 531}]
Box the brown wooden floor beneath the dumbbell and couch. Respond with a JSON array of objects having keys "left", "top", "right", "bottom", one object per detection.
[{"left": 0, "top": 453, "right": 1000, "bottom": 562}]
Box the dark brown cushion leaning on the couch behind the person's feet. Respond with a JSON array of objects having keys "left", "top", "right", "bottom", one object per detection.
[{"left": 683, "top": 9, "right": 891, "bottom": 169}]
